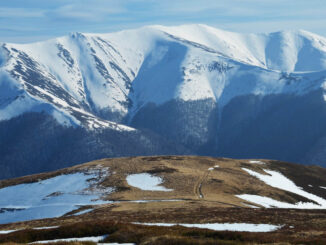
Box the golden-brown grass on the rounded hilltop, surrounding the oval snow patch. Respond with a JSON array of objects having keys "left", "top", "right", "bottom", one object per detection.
[{"left": 0, "top": 156, "right": 326, "bottom": 207}]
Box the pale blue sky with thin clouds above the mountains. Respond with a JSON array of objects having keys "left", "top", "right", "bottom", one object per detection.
[{"left": 0, "top": 0, "right": 326, "bottom": 43}]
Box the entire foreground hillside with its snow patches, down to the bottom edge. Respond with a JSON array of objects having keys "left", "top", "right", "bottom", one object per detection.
[{"left": 0, "top": 156, "right": 326, "bottom": 244}]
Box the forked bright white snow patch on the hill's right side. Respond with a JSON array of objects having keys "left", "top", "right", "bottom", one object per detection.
[{"left": 236, "top": 168, "right": 326, "bottom": 209}]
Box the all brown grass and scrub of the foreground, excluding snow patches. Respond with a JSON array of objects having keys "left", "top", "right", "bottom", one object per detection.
[{"left": 0, "top": 156, "right": 326, "bottom": 244}]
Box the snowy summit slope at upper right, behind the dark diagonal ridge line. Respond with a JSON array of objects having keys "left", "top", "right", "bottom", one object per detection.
[{"left": 156, "top": 25, "right": 326, "bottom": 72}]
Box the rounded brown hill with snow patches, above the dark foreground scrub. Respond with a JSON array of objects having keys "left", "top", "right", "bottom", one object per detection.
[{"left": 0, "top": 156, "right": 326, "bottom": 223}]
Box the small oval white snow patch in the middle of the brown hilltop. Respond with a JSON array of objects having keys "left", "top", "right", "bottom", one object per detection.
[{"left": 126, "top": 173, "right": 173, "bottom": 191}]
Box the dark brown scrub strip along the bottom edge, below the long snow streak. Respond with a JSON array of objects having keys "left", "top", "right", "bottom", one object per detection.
[{"left": 0, "top": 217, "right": 326, "bottom": 245}]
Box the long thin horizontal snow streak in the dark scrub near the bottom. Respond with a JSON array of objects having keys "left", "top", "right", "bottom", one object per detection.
[{"left": 134, "top": 223, "right": 281, "bottom": 232}]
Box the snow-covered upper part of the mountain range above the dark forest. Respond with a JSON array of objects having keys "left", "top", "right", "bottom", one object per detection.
[{"left": 0, "top": 25, "right": 326, "bottom": 131}]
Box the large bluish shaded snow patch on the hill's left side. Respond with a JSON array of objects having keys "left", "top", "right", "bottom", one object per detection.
[{"left": 0, "top": 173, "right": 113, "bottom": 224}]
